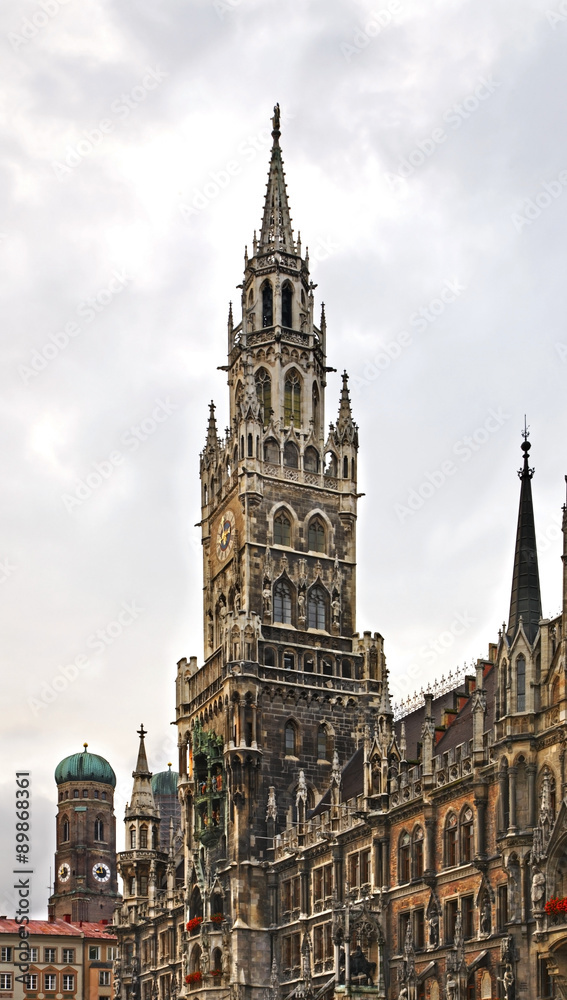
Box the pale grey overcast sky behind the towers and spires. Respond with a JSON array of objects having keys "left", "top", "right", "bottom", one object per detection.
[{"left": 0, "top": 0, "right": 567, "bottom": 915}]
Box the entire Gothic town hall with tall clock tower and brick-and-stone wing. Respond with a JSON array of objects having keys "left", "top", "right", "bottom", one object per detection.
[{"left": 110, "top": 107, "right": 567, "bottom": 1000}]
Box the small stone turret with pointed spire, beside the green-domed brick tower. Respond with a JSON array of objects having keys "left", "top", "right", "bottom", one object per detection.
[{"left": 118, "top": 725, "right": 168, "bottom": 912}]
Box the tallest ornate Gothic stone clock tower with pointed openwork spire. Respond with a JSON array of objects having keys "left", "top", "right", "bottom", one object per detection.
[{"left": 176, "top": 106, "right": 392, "bottom": 996}]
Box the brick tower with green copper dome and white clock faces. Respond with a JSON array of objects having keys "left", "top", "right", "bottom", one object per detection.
[{"left": 49, "top": 743, "right": 120, "bottom": 922}]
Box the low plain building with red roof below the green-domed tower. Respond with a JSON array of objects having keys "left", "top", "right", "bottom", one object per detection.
[{"left": 0, "top": 917, "right": 118, "bottom": 1000}]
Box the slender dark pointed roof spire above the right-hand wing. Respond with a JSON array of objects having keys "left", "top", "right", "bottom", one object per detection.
[{"left": 506, "top": 425, "right": 541, "bottom": 643}]
